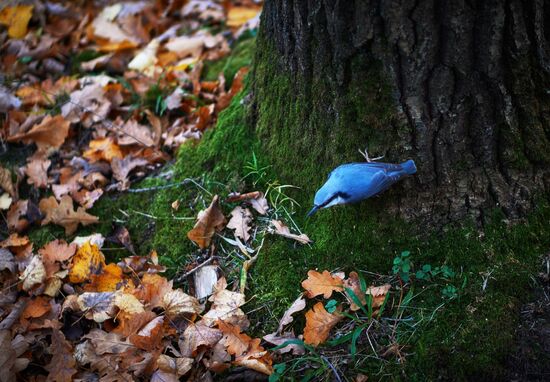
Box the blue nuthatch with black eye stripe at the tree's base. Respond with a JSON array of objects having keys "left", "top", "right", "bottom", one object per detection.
[{"left": 307, "top": 150, "right": 416, "bottom": 216}]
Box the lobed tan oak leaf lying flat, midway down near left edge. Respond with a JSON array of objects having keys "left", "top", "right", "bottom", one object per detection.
[{"left": 38, "top": 195, "right": 99, "bottom": 235}]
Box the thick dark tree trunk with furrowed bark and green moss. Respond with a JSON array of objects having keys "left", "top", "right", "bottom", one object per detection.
[{"left": 253, "top": 0, "right": 550, "bottom": 225}]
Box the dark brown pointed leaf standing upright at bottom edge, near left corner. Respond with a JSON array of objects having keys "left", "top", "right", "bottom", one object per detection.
[{"left": 46, "top": 329, "right": 77, "bottom": 382}]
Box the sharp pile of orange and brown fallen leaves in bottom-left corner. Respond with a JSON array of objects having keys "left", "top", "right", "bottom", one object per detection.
[{"left": 0, "top": 234, "right": 273, "bottom": 381}]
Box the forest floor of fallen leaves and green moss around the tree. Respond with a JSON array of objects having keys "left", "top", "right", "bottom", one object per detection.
[{"left": 0, "top": 0, "right": 550, "bottom": 381}]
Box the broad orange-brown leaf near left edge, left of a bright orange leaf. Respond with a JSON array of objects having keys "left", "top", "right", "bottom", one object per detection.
[{"left": 7, "top": 115, "right": 71, "bottom": 151}]
